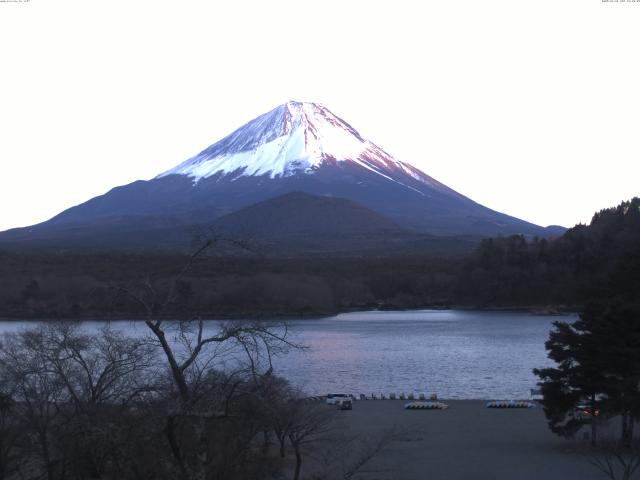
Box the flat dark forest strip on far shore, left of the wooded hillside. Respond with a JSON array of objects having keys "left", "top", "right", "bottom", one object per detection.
[{"left": 0, "top": 253, "right": 459, "bottom": 319}]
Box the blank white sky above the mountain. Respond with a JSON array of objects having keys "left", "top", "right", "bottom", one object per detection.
[{"left": 0, "top": 0, "right": 640, "bottom": 230}]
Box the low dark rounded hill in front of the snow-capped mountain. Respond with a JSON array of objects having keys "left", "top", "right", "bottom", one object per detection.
[{"left": 210, "top": 192, "right": 436, "bottom": 257}]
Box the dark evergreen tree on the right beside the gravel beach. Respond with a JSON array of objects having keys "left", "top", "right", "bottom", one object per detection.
[{"left": 534, "top": 300, "right": 640, "bottom": 447}]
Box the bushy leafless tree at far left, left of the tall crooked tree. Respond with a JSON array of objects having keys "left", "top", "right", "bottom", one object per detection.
[{"left": 0, "top": 322, "right": 158, "bottom": 480}]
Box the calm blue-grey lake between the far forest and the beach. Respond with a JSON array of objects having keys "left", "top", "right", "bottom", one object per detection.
[{"left": 0, "top": 310, "right": 576, "bottom": 399}]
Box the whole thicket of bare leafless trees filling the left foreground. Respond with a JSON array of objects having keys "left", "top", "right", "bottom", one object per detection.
[{"left": 0, "top": 322, "right": 389, "bottom": 480}]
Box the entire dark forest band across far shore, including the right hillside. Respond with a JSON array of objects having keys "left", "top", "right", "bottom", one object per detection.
[{"left": 0, "top": 198, "right": 640, "bottom": 318}]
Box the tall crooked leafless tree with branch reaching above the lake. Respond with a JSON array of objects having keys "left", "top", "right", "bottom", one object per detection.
[{"left": 118, "top": 238, "right": 304, "bottom": 480}]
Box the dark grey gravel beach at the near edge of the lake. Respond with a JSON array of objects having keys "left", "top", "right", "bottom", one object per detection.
[{"left": 303, "top": 400, "right": 606, "bottom": 480}]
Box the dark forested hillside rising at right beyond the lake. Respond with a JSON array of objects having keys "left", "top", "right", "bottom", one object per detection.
[{"left": 455, "top": 198, "right": 640, "bottom": 305}]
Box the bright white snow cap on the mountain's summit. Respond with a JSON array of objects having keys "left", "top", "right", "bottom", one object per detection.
[{"left": 157, "top": 101, "right": 446, "bottom": 194}]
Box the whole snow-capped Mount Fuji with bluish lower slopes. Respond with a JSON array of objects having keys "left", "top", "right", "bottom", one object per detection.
[{"left": 0, "top": 102, "right": 563, "bottom": 253}]
